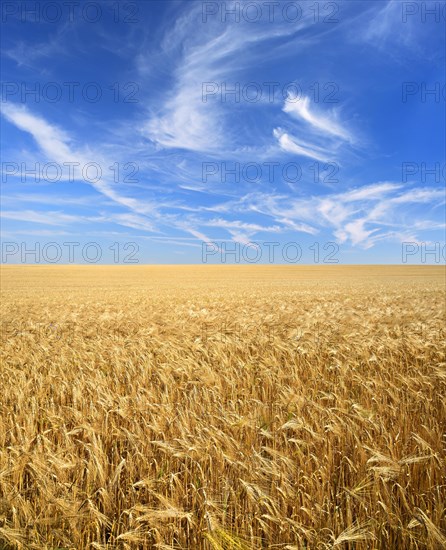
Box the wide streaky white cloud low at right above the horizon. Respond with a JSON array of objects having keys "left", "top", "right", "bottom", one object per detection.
[{"left": 199, "top": 182, "right": 445, "bottom": 249}]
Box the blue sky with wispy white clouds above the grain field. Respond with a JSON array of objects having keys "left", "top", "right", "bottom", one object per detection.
[{"left": 1, "top": 0, "right": 446, "bottom": 263}]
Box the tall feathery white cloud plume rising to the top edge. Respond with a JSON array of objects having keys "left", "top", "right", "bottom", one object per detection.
[{"left": 138, "top": 2, "right": 318, "bottom": 154}]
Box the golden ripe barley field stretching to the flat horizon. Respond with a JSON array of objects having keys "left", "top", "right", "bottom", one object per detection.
[{"left": 0, "top": 265, "right": 446, "bottom": 550}]
